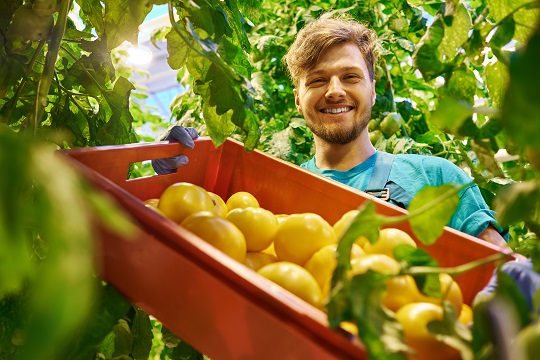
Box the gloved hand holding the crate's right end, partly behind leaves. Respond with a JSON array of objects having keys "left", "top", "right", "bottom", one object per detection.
[{"left": 474, "top": 260, "right": 540, "bottom": 311}]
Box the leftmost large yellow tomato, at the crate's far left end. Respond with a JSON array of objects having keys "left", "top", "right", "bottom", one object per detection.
[{"left": 158, "top": 182, "right": 214, "bottom": 224}]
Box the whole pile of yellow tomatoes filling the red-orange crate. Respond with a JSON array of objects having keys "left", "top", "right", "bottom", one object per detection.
[{"left": 145, "top": 182, "right": 472, "bottom": 359}]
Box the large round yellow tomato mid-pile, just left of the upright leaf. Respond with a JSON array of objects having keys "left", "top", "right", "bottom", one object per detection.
[{"left": 274, "top": 213, "right": 336, "bottom": 266}]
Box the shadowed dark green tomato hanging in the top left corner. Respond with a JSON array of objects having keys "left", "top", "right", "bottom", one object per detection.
[{"left": 9, "top": 5, "right": 54, "bottom": 41}]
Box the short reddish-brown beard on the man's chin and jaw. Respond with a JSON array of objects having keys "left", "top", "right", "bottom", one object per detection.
[{"left": 306, "top": 108, "right": 371, "bottom": 145}]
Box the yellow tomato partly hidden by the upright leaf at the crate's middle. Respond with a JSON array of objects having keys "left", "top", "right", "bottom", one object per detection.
[{"left": 304, "top": 244, "right": 364, "bottom": 299}]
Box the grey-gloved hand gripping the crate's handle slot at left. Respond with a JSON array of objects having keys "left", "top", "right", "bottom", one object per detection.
[{"left": 152, "top": 125, "right": 199, "bottom": 175}]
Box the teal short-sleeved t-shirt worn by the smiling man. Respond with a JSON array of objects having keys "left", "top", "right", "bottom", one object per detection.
[{"left": 301, "top": 151, "right": 507, "bottom": 238}]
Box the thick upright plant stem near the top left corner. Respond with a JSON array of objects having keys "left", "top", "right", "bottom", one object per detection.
[{"left": 29, "top": 0, "right": 72, "bottom": 135}]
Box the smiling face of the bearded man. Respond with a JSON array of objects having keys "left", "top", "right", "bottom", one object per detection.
[{"left": 294, "top": 43, "right": 375, "bottom": 144}]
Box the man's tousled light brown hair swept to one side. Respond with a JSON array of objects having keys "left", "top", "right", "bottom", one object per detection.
[{"left": 283, "top": 14, "right": 377, "bottom": 86}]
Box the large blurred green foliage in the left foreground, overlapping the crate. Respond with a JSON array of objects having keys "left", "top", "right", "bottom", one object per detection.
[{"left": 0, "top": 126, "right": 134, "bottom": 359}]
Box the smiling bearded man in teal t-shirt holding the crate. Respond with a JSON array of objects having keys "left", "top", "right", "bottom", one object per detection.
[{"left": 284, "top": 14, "right": 508, "bottom": 248}]
